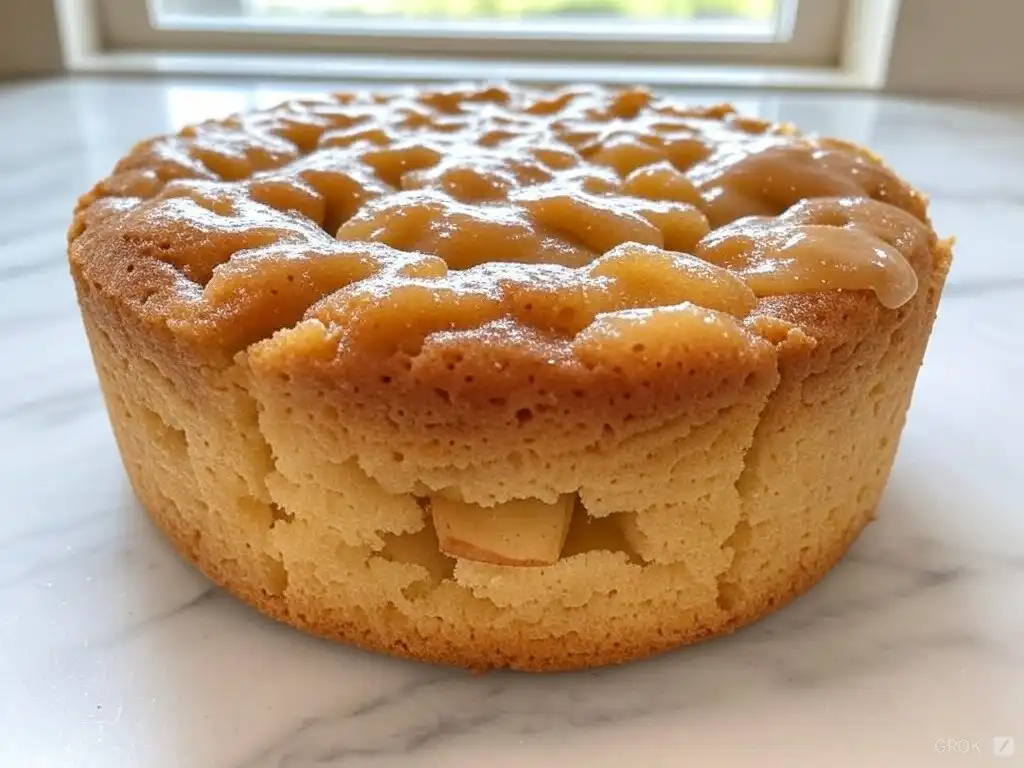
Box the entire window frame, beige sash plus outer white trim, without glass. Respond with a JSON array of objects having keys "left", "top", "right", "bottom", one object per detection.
[{"left": 54, "top": 0, "right": 901, "bottom": 90}]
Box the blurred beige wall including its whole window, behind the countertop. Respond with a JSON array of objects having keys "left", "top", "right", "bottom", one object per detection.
[{"left": 0, "top": 0, "right": 1024, "bottom": 99}]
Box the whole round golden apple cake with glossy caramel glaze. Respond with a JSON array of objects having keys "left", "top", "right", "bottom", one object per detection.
[{"left": 69, "top": 86, "right": 950, "bottom": 670}]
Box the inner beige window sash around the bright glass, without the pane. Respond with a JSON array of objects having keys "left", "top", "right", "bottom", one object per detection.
[{"left": 95, "top": 0, "right": 851, "bottom": 66}]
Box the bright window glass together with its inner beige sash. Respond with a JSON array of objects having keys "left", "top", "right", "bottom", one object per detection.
[{"left": 92, "top": 0, "right": 862, "bottom": 68}]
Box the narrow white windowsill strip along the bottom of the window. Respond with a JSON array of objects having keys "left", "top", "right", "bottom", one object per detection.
[{"left": 69, "top": 51, "right": 871, "bottom": 90}]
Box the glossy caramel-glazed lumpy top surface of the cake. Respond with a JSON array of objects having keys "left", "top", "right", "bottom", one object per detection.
[{"left": 70, "top": 86, "right": 933, "bottom": 368}]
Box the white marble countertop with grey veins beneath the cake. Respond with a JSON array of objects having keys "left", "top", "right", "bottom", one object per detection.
[{"left": 0, "top": 80, "right": 1024, "bottom": 768}]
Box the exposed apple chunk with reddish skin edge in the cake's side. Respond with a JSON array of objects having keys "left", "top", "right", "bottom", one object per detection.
[{"left": 430, "top": 494, "right": 575, "bottom": 565}]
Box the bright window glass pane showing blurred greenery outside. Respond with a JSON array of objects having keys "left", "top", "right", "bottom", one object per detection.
[{"left": 151, "top": 0, "right": 782, "bottom": 40}]
